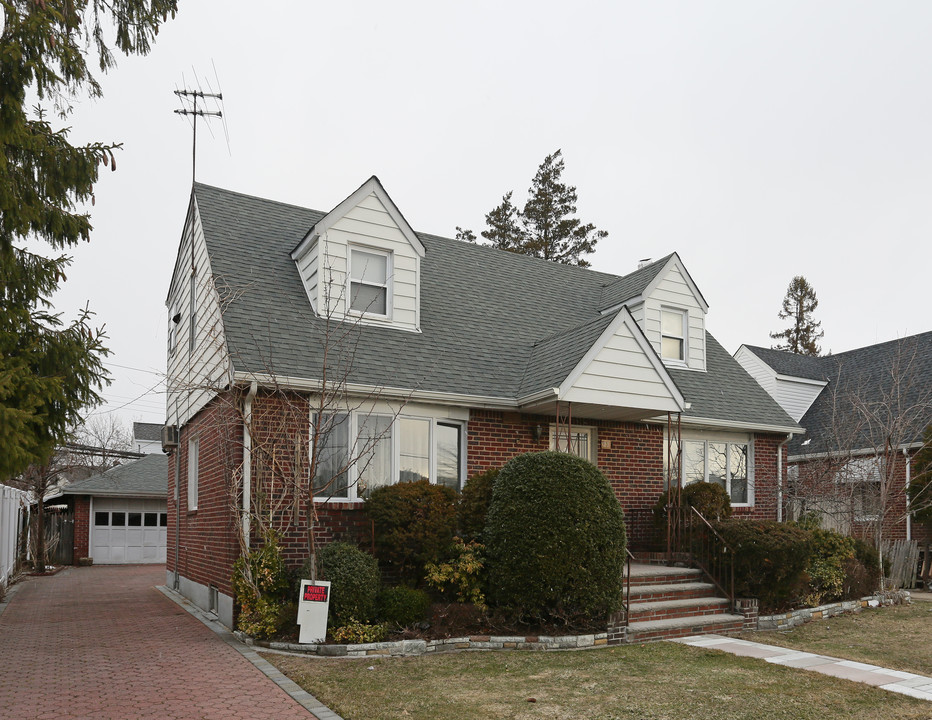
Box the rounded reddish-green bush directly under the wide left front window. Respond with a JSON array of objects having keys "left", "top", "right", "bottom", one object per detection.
[{"left": 365, "top": 480, "right": 457, "bottom": 586}]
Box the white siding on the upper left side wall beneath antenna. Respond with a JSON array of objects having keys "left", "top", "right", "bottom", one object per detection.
[{"left": 167, "top": 202, "right": 230, "bottom": 425}]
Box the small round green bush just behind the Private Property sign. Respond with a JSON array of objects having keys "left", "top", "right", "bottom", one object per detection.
[{"left": 314, "top": 542, "right": 381, "bottom": 627}]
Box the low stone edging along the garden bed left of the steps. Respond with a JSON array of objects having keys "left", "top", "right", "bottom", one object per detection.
[{"left": 235, "top": 631, "right": 608, "bottom": 657}]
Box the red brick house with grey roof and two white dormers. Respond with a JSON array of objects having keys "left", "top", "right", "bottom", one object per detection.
[{"left": 166, "top": 177, "right": 801, "bottom": 624}]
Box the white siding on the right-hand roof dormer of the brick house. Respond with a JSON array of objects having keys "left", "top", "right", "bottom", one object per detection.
[{"left": 631, "top": 257, "right": 707, "bottom": 371}]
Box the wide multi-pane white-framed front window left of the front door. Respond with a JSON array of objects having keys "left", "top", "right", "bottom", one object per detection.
[{"left": 311, "top": 412, "right": 465, "bottom": 500}]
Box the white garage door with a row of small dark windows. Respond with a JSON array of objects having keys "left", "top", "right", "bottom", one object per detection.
[{"left": 90, "top": 498, "right": 168, "bottom": 565}]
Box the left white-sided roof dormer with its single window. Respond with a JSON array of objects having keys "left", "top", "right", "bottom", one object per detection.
[{"left": 291, "top": 176, "right": 425, "bottom": 331}]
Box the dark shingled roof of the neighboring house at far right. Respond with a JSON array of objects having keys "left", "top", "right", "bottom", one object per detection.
[{"left": 747, "top": 332, "right": 932, "bottom": 455}]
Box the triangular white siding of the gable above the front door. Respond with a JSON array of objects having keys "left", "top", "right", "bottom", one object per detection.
[{"left": 562, "top": 324, "right": 675, "bottom": 412}]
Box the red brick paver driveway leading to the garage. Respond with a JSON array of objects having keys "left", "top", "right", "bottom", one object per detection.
[{"left": 0, "top": 565, "right": 314, "bottom": 720}]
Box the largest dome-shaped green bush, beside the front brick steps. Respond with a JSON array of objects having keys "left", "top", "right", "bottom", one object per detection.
[{"left": 483, "top": 452, "right": 626, "bottom": 623}]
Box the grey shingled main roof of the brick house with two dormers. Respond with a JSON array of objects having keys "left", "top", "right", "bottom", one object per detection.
[{"left": 194, "top": 183, "right": 796, "bottom": 428}]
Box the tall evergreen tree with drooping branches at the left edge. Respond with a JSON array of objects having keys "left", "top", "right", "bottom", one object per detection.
[{"left": 0, "top": 0, "right": 177, "bottom": 481}]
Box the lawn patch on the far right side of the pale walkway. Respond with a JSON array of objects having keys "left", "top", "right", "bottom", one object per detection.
[{"left": 741, "top": 602, "right": 932, "bottom": 676}]
